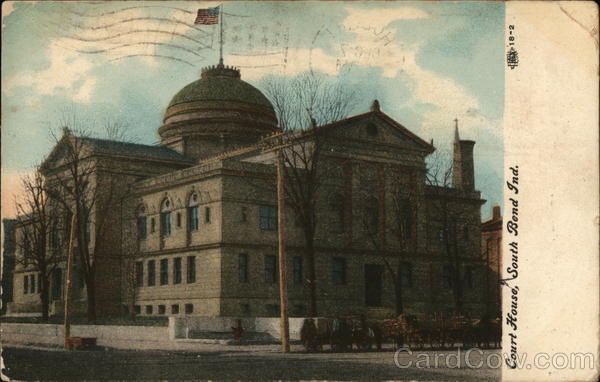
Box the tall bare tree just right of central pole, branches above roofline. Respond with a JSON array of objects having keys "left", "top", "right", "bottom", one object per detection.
[{"left": 262, "top": 73, "right": 354, "bottom": 316}]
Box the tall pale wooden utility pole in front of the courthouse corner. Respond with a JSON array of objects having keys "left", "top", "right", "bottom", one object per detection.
[{"left": 277, "top": 148, "right": 290, "bottom": 353}]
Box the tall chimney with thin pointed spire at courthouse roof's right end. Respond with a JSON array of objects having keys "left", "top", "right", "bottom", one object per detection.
[{"left": 452, "top": 119, "right": 475, "bottom": 191}]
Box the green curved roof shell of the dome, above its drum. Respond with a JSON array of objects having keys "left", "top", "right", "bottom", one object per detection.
[{"left": 167, "top": 66, "right": 273, "bottom": 111}]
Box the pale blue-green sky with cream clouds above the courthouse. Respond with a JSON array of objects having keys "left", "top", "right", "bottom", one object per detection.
[{"left": 1, "top": 1, "right": 504, "bottom": 218}]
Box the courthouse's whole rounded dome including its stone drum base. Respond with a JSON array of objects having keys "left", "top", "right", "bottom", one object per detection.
[{"left": 158, "top": 64, "right": 278, "bottom": 159}]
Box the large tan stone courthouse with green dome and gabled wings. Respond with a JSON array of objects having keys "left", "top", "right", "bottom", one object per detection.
[{"left": 9, "top": 64, "right": 486, "bottom": 316}]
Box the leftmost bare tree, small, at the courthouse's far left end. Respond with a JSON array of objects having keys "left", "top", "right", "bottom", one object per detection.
[{"left": 16, "top": 169, "right": 69, "bottom": 321}]
